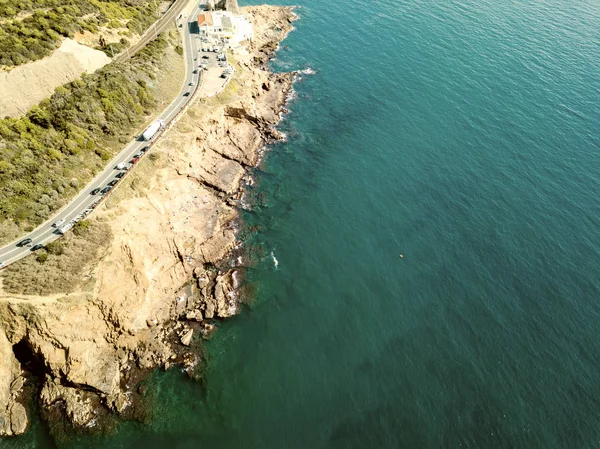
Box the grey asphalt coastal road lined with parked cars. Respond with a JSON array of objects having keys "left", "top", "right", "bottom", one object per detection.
[{"left": 0, "top": 0, "right": 205, "bottom": 268}]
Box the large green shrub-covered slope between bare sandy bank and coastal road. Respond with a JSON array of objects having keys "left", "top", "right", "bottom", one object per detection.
[{"left": 0, "top": 32, "right": 178, "bottom": 240}]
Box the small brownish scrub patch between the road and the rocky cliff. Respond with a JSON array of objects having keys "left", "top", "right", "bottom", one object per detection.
[{"left": 2, "top": 220, "right": 112, "bottom": 295}]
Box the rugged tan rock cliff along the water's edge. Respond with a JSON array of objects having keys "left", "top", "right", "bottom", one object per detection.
[{"left": 0, "top": 6, "right": 293, "bottom": 435}]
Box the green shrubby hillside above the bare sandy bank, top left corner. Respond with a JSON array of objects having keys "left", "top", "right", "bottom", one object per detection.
[{"left": 0, "top": 0, "right": 156, "bottom": 67}]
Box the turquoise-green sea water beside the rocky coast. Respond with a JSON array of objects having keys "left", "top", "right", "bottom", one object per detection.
[{"left": 5, "top": 0, "right": 600, "bottom": 448}]
